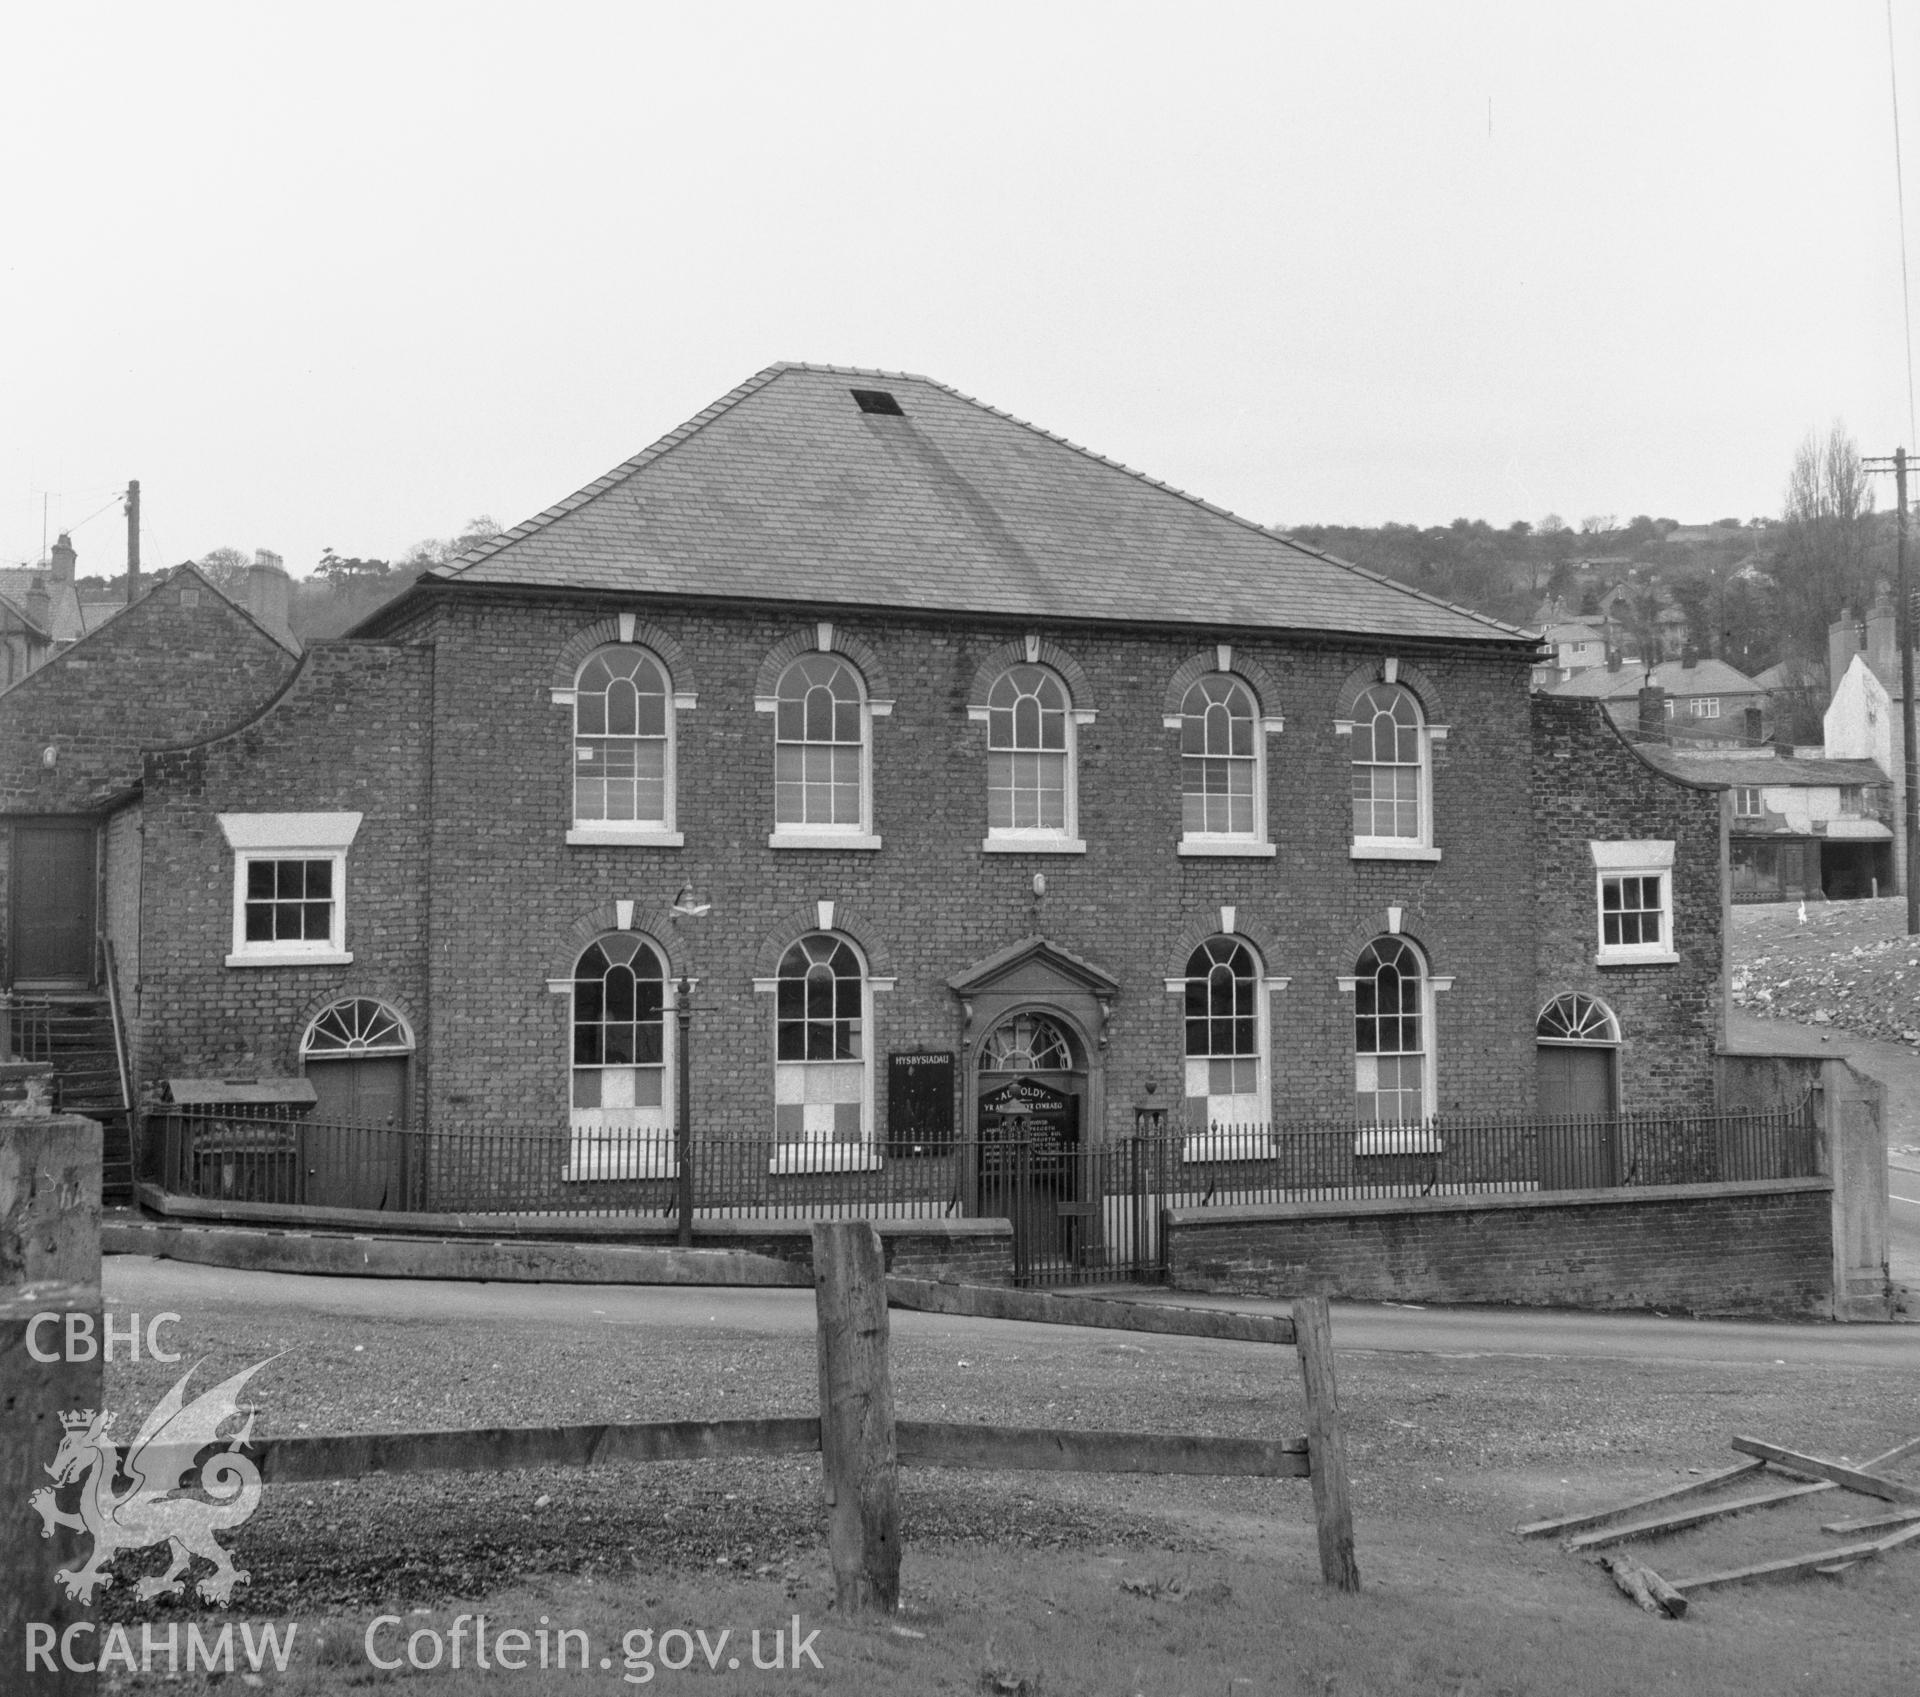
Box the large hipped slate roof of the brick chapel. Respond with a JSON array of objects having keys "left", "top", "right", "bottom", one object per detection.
[{"left": 416, "top": 365, "right": 1536, "bottom": 649}]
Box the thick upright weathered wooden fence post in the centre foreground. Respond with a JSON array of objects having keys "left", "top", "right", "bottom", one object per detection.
[{"left": 814, "top": 1219, "right": 900, "bottom": 1614}]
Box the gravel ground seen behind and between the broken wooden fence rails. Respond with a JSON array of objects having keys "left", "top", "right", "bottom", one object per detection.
[{"left": 90, "top": 1288, "right": 1920, "bottom": 1620}]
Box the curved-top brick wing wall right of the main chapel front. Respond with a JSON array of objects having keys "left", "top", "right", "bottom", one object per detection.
[{"left": 1530, "top": 695, "right": 1728, "bottom": 1113}]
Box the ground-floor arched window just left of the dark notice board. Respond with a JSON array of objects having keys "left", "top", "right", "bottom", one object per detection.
[{"left": 774, "top": 931, "right": 874, "bottom": 1167}]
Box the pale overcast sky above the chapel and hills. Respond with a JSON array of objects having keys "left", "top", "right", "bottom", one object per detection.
[{"left": 0, "top": 0, "right": 1920, "bottom": 574}]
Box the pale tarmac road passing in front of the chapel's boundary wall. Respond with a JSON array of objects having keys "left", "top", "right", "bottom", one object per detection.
[{"left": 102, "top": 1255, "right": 1920, "bottom": 1371}]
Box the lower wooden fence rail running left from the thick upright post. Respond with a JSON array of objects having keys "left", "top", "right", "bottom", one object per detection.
[{"left": 133, "top": 1419, "right": 820, "bottom": 1484}]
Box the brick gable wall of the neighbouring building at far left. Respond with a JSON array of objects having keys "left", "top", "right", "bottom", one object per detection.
[{"left": 0, "top": 570, "right": 294, "bottom": 983}]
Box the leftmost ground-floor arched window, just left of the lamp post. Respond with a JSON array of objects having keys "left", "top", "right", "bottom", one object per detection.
[{"left": 568, "top": 931, "right": 674, "bottom": 1179}]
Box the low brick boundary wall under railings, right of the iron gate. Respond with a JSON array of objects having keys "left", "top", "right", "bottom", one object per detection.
[{"left": 1165, "top": 1179, "right": 1834, "bottom": 1317}]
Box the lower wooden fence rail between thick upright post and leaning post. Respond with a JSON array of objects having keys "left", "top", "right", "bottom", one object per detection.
[{"left": 895, "top": 1421, "right": 1308, "bottom": 1478}]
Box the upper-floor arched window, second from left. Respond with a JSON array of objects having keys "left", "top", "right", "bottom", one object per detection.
[{"left": 774, "top": 655, "right": 872, "bottom": 847}]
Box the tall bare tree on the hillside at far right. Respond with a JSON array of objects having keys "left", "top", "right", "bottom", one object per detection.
[{"left": 1770, "top": 422, "right": 1874, "bottom": 655}]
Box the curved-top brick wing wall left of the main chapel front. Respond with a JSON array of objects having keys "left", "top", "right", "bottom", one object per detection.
[{"left": 131, "top": 643, "right": 433, "bottom": 1113}]
